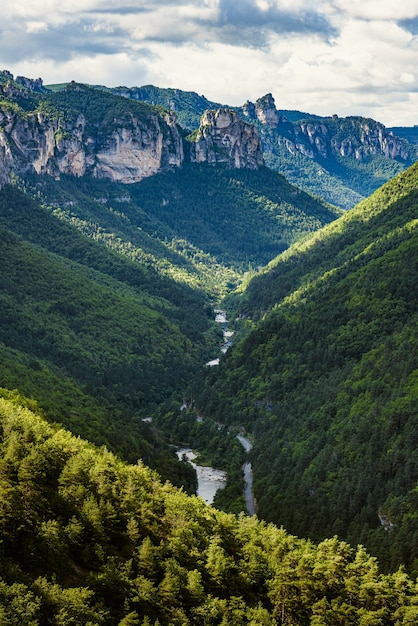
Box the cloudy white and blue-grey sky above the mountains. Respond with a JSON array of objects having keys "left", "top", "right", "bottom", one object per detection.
[{"left": 0, "top": 0, "right": 418, "bottom": 126}]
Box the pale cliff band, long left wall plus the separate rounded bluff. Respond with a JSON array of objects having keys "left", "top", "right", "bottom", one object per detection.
[{"left": 0, "top": 72, "right": 264, "bottom": 185}]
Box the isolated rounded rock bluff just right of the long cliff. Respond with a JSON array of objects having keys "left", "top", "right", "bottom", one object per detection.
[{"left": 191, "top": 109, "right": 264, "bottom": 169}]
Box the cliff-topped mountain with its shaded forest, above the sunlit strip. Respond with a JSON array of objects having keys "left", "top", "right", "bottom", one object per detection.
[{"left": 0, "top": 73, "right": 337, "bottom": 280}]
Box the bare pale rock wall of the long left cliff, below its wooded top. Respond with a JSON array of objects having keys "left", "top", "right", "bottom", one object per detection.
[{"left": 0, "top": 81, "right": 184, "bottom": 185}]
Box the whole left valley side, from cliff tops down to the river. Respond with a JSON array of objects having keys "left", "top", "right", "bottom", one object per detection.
[{"left": 0, "top": 73, "right": 336, "bottom": 488}]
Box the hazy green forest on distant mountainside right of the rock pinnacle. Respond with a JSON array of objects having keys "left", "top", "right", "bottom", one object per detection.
[{"left": 252, "top": 116, "right": 417, "bottom": 209}]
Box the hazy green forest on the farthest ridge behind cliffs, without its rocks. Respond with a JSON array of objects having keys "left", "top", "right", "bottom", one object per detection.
[{"left": 115, "top": 85, "right": 417, "bottom": 209}]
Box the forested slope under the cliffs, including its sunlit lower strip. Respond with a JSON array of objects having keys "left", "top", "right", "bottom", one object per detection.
[{"left": 19, "top": 163, "right": 340, "bottom": 298}]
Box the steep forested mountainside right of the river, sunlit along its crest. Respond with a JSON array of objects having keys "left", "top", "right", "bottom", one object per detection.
[{"left": 189, "top": 166, "right": 418, "bottom": 571}]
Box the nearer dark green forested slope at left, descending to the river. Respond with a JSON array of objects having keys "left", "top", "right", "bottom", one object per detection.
[{"left": 0, "top": 187, "right": 218, "bottom": 480}]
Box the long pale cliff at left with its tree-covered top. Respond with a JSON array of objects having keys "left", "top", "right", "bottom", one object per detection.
[{"left": 0, "top": 75, "right": 184, "bottom": 183}]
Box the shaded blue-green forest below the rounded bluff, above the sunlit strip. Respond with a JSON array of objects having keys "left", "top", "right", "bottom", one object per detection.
[{"left": 125, "top": 164, "right": 338, "bottom": 272}]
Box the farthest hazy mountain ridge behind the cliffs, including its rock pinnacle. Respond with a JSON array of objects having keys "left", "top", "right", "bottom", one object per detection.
[{"left": 117, "top": 85, "right": 417, "bottom": 209}]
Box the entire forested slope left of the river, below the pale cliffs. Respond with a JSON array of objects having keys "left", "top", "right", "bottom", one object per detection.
[{"left": 0, "top": 146, "right": 336, "bottom": 485}]
